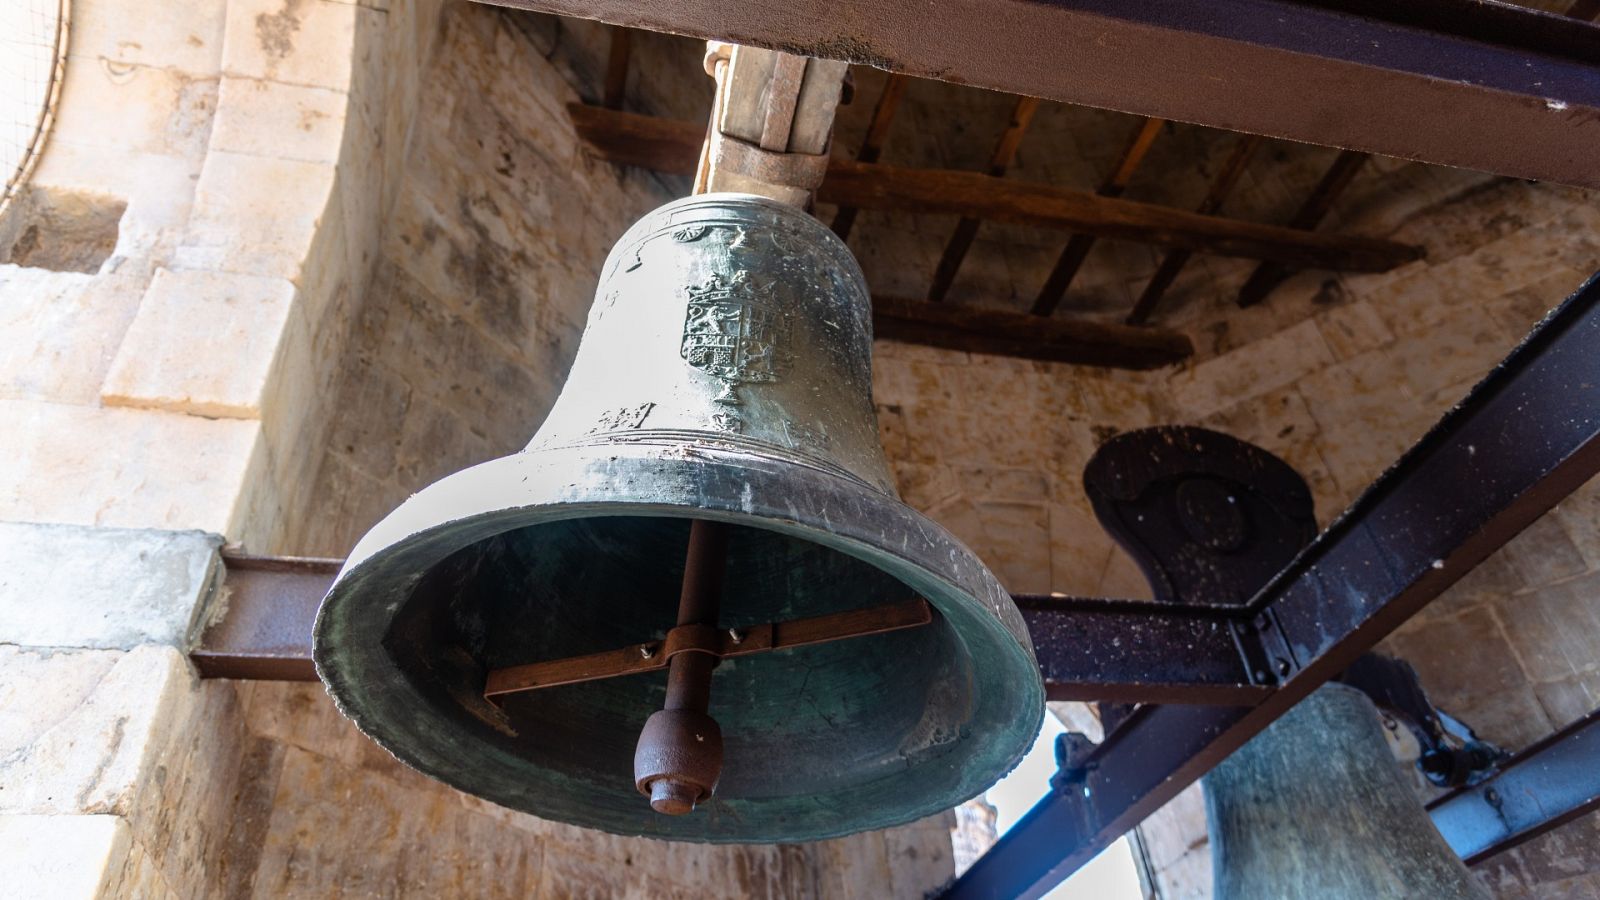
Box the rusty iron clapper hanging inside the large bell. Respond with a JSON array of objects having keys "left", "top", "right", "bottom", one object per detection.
[{"left": 634, "top": 519, "right": 730, "bottom": 815}]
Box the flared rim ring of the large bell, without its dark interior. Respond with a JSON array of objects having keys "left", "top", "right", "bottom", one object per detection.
[{"left": 312, "top": 447, "right": 1045, "bottom": 844}]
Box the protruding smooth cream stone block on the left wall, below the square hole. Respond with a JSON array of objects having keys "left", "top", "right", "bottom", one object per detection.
[{"left": 101, "top": 269, "right": 296, "bottom": 418}]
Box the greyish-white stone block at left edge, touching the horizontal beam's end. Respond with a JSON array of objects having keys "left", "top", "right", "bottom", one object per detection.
[{"left": 0, "top": 522, "right": 222, "bottom": 649}]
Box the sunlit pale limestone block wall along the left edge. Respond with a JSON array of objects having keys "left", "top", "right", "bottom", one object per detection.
[{"left": 0, "top": 0, "right": 457, "bottom": 897}]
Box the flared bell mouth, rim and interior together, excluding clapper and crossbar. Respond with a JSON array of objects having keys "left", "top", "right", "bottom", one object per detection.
[{"left": 315, "top": 447, "right": 1043, "bottom": 842}]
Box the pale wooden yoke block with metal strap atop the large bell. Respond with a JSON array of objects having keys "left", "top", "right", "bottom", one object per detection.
[{"left": 694, "top": 40, "right": 848, "bottom": 210}]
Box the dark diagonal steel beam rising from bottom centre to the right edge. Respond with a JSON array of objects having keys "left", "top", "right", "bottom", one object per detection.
[{"left": 946, "top": 267, "right": 1600, "bottom": 900}]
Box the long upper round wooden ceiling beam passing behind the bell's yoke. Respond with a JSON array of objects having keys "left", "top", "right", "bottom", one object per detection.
[{"left": 568, "top": 104, "right": 1422, "bottom": 272}]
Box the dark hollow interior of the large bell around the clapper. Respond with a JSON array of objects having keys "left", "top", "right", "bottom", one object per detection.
[{"left": 382, "top": 516, "right": 974, "bottom": 820}]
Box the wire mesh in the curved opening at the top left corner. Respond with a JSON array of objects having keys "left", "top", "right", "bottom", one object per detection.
[{"left": 0, "top": 0, "right": 69, "bottom": 215}]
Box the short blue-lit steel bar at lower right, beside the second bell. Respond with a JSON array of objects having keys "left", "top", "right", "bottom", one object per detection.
[{"left": 1427, "top": 709, "right": 1600, "bottom": 863}]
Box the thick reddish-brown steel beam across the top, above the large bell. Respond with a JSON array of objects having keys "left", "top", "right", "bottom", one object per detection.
[{"left": 480, "top": 0, "right": 1600, "bottom": 187}]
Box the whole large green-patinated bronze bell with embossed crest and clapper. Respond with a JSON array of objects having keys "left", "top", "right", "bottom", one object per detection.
[{"left": 315, "top": 194, "right": 1043, "bottom": 842}]
